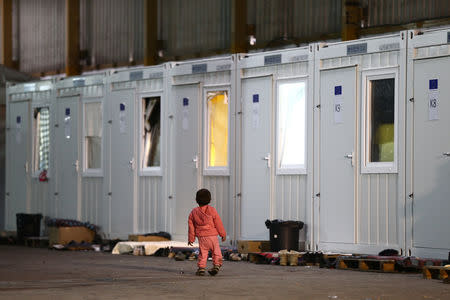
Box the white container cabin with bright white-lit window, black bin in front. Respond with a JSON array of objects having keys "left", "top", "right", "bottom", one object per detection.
[{"left": 237, "top": 45, "right": 314, "bottom": 248}]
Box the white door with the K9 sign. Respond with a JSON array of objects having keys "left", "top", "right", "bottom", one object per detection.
[{"left": 318, "top": 67, "right": 356, "bottom": 249}]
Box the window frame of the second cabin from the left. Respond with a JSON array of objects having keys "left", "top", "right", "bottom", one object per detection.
[{"left": 81, "top": 98, "right": 105, "bottom": 177}]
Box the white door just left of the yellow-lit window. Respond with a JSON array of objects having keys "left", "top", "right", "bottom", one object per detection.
[{"left": 173, "top": 84, "right": 202, "bottom": 240}]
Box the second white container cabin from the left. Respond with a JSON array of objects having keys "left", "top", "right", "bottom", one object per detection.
[{"left": 52, "top": 73, "right": 106, "bottom": 225}]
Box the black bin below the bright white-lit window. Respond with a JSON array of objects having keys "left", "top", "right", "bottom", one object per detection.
[{"left": 266, "top": 220, "right": 304, "bottom": 252}]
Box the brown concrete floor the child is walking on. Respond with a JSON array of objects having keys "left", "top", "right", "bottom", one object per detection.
[{"left": 0, "top": 246, "right": 450, "bottom": 300}]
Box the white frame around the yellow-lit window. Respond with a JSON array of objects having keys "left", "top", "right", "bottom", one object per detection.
[{"left": 202, "top": 85, "right": 231, "bottom": 176}]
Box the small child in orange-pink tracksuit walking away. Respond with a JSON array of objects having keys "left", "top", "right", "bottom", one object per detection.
[{"left": 188, "top": 189, "right": 227, "bottom": 276}]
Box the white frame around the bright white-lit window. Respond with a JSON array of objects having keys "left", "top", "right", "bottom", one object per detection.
[{"left": 275, "top": 76, "right": 308, "bottom": 175}]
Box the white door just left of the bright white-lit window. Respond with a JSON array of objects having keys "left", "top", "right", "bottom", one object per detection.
[{"left": 240, "top": 76, "right": 274, "bottom": 240}]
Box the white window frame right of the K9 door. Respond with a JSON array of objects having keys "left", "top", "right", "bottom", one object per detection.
[{"left": 360, "top": 68, "right": 399, "bottom": 174}]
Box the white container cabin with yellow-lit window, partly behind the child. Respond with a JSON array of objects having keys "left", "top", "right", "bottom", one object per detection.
[{"left": 169, "top": 56, "right": 236, "bottom": 241}]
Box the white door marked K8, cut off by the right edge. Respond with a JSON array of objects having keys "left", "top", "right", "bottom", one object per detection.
[{"left": 412, "top": 57, "right": 450, "bottom": 258}]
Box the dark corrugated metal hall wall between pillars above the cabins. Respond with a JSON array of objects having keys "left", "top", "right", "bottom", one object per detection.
[{"left": 5, "top": 0, "right": 450, "bottom": 72}]
